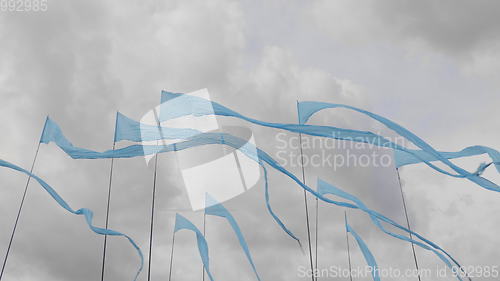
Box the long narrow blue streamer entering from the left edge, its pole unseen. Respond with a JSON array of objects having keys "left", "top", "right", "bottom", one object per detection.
[{"left": 0, "top": 159, "right": 144, "bottom": 281}]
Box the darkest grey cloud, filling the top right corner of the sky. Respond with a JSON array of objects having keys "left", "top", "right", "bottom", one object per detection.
[{"left": 373, "top": 1, "right": 500, "bottom": 55}]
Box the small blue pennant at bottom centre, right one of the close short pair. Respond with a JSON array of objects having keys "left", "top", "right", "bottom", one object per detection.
[{"left": 205, "top": 194, "right": 261, "bottom": 281}]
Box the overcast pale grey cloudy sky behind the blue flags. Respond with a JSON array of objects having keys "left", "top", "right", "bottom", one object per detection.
[{"left": 0, "top": 0, "right": 500, "bottom": 281}]
